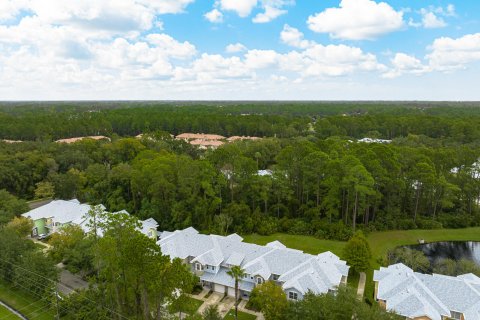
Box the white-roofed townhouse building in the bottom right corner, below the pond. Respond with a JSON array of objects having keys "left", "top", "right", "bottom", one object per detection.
[{"left": 373, "top": 263, "right": 480, "bottom": 320}]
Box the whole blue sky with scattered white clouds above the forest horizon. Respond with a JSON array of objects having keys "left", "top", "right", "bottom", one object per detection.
[{"left": 0, "top": 0, "right": 480, "bottom": 101}]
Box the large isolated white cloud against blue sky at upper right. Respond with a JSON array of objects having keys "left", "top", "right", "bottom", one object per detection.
[{"left": 307, "top": 0, "right": 404, "bottom": 40}]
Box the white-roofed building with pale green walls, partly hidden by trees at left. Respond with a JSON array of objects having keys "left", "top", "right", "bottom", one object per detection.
[{"left": 22, "top": 199, "right": 158, "bottom": 240}]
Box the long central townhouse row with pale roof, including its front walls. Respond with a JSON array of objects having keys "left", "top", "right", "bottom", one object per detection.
[{"left": 157, "top": 228, "right": 349, "bottom": 300}]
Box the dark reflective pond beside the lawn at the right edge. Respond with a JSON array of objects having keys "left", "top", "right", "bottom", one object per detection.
[{"left": 407, "top": 241, "right": 480, "bottom": 266}]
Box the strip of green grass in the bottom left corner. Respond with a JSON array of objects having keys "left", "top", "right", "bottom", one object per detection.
[{"left": 0, "top": 281, "right": 55, "bottom": 320}]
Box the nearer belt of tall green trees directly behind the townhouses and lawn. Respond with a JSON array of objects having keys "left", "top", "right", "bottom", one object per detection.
[{"left": 0, "top": 132, "right": 480, "bottom": 239}]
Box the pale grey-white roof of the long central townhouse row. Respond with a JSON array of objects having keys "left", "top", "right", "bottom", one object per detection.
[{"left": 157, "top": 228, "right": 349, "bottom": 293}]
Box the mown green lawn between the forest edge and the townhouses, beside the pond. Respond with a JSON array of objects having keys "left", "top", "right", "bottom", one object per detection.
[{"left": 244, "top": 227, "right": 480, "bottom": 300}]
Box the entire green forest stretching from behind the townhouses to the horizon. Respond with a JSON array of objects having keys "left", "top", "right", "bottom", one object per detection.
[{"left": 0, "top": 102, "right": 480, "bottom": 240}]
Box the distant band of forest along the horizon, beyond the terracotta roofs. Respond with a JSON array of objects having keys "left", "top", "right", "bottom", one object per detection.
[{"left": 0, "top": 102, "right": 480, "bottom": 144}]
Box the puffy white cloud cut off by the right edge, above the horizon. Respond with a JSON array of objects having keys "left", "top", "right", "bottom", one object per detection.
[{"left": 426, "top": 33, "right": 480, "bottom": 71}]
